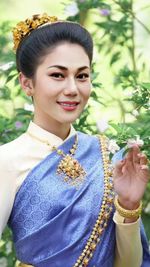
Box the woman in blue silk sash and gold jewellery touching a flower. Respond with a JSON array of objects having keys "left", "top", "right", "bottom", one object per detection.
[{"left": 0, "top": 14, "right": 150, "bottom": 267}]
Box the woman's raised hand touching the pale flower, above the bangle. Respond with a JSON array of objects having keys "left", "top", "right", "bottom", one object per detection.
[{"left": 113, "top": 145, "right": 150, "bottom": 210}]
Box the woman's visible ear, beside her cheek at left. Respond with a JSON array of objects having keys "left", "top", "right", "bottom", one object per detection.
[{"left": 19, "top": 72, "right": 34, "bottom": 96}]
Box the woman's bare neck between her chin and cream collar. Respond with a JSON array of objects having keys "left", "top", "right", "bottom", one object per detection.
[{"left": 33, "top": 116, "right": 71, "bottom": 140}]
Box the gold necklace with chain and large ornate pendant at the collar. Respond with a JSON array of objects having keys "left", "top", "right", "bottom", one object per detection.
[{"left": 26, "top": 131, "right": 86, "bottom": 187}]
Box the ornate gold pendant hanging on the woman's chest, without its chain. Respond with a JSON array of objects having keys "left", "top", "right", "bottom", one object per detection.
[{"left": 57, "top": 154, "right": 86, "bottom": 186}]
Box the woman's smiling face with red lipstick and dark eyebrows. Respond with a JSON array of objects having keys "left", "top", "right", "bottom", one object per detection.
[{"left": 21, "top": 43, "right": 91, "bottom": 132}]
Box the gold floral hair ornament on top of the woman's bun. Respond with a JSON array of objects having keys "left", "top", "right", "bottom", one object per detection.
[{"left": 12, "top": 13, "right": 58, "bottom": 51}]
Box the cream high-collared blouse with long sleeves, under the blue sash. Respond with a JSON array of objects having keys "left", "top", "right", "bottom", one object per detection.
[{"left": 0, "top": 122, "right": 142, "bottom": 267}]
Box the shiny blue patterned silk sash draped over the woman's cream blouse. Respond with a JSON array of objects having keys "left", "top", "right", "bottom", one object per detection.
[{"left": 9, "top": 133, "right": 150, "bottom": 267}]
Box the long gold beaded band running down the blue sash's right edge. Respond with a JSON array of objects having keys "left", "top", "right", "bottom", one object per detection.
[{"left": 73, "top": 135, "right": 114, "bottom": 267}]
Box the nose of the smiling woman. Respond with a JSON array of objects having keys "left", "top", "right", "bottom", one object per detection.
[{"left": 64, "top": 77, "right": 78, "bottom": 96}]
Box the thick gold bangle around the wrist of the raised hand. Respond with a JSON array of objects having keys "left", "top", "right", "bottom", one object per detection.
[{"left": 114, "top": 196, "right": 142, "bottom": 219}]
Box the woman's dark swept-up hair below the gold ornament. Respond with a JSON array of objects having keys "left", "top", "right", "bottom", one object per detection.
[{"left": 16, "top": 21, "right": 93, "bottom": 78}]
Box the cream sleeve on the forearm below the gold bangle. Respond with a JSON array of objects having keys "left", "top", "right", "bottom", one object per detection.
[{"left": 113, "top": 211, "right": 143, "bottom": 267}]
